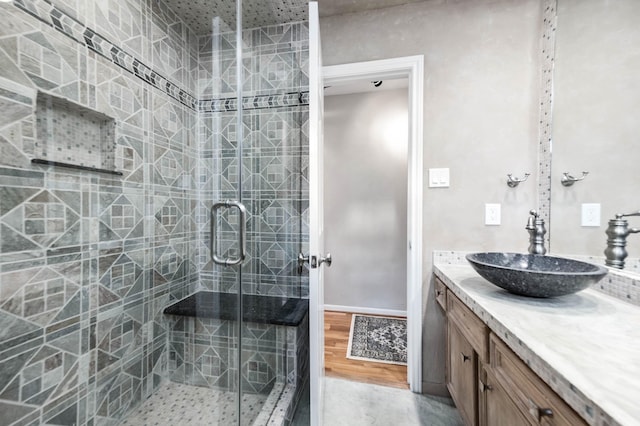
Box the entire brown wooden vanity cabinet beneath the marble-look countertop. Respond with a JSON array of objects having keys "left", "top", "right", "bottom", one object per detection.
[{"left": 436, "top": 280, "right": 587, "bottom": 426}]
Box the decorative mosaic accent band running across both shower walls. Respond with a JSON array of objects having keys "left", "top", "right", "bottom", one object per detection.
[{"left": 13, "top": 0, "right": 309, "bottom": 112}]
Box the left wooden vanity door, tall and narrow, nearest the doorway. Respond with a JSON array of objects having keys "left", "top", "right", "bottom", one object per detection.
[{"left": 447, "top": 320, "right": 478, "bottom": 426}]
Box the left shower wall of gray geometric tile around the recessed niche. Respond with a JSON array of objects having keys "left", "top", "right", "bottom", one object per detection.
[{"left": 0, "top": 0, "right": 198, "bottom": 425}]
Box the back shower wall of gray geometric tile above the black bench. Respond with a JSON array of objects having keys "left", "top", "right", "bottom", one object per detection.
[{"left": 198, "top": 22, "right": 309, "bottom": 297}]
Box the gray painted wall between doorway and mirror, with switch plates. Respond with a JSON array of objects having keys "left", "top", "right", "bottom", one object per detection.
[{"left": 320, "top": 0, "right": 542, "bottom": 394}]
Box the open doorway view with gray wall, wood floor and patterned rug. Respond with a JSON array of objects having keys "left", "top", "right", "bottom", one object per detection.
[{"left": 323, "top": 78, "right": 409, "bottom": 389}]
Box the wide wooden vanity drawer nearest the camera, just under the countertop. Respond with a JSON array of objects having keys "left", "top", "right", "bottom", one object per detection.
[{"left": 489, "top": 333, "right": 587, "bottom": 426}]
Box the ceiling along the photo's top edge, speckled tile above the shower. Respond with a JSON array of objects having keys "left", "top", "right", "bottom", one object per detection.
[{"left": 165, "top": 0, "right": 424, "bottom": 35}]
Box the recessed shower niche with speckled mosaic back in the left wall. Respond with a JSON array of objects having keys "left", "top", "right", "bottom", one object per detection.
[{"left": 34, "top": 92, "right": 116, "bottom": 170}]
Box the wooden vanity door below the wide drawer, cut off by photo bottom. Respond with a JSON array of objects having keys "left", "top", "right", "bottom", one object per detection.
[{"left": 481, "top": 368, "right": 530, "bottom": 426}]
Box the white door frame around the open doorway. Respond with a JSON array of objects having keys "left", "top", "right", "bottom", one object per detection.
[{"left": 320, "top": 55, "right": 424, "bottom": 393}]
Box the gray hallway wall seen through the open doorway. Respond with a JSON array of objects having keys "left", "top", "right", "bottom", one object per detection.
[{"left": 324, "top": 87, "right": 408, "bottom": 311}]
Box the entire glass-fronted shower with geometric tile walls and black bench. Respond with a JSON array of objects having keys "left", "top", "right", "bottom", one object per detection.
[{"left": 0, "top": 0, "right": 309, "bottom": 425}]
